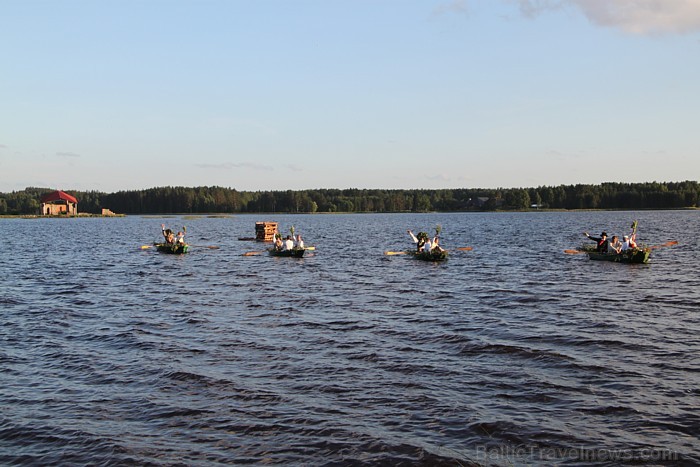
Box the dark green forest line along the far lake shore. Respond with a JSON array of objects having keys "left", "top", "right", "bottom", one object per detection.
[{"left": 0, "top": 181, "right": 700, "bottom": 215}]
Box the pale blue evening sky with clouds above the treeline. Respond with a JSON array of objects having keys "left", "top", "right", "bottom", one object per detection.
[{"left": 0, "top": 0, "right": 700, "bottom": 193}]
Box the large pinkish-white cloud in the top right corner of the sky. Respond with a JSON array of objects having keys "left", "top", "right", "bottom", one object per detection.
[{"left": 510, "top": 0, "right": 700, "bottom": 35}]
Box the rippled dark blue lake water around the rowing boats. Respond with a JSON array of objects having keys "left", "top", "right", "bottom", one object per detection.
[{"left": 0, "top": 211, "right": 700, "bottom": 465}]
